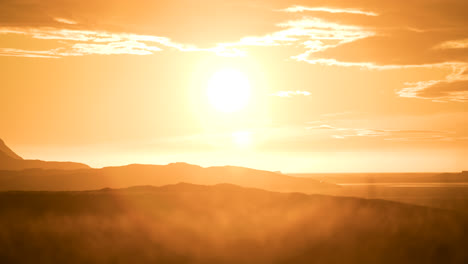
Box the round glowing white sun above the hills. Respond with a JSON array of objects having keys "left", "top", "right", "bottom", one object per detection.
[{"left": 207, "top": 69, "right": 250, "bottom": 113}]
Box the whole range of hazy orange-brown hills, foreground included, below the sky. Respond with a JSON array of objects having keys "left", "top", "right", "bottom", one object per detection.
[{"left": 0, "top": 138, "right": 468, "bottom": 264}]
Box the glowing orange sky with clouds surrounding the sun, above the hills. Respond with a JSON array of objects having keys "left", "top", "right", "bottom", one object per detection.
[{"left": 0, "top": 0, "right": 468, "bottom": 172}]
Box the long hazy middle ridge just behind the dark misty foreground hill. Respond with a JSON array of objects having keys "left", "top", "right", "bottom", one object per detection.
[{"left": 0, "top": 163, "right": 339, "bottom": 193}]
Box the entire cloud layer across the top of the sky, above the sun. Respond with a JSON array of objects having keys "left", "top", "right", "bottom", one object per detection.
[{"left": 0, "top": 0, "right": 468, "bottom": 72}]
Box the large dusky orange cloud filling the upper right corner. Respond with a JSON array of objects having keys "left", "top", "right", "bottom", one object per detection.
[{"left": 276, "top": 0, "right": 468, "bottom": 66}]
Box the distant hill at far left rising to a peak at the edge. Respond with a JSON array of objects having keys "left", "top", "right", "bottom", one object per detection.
[{"left": 0, "top": 139, "right": 89, "bottom": 170}]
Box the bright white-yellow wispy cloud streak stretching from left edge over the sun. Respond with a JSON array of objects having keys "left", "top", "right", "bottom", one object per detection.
[{"left": 0, "top": 9, "right": 375, "bottom": 60}]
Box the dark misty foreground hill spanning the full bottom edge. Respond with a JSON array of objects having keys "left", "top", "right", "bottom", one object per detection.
[{"left": 0, "top": 184, "right": 468, "bottom": 264}]
